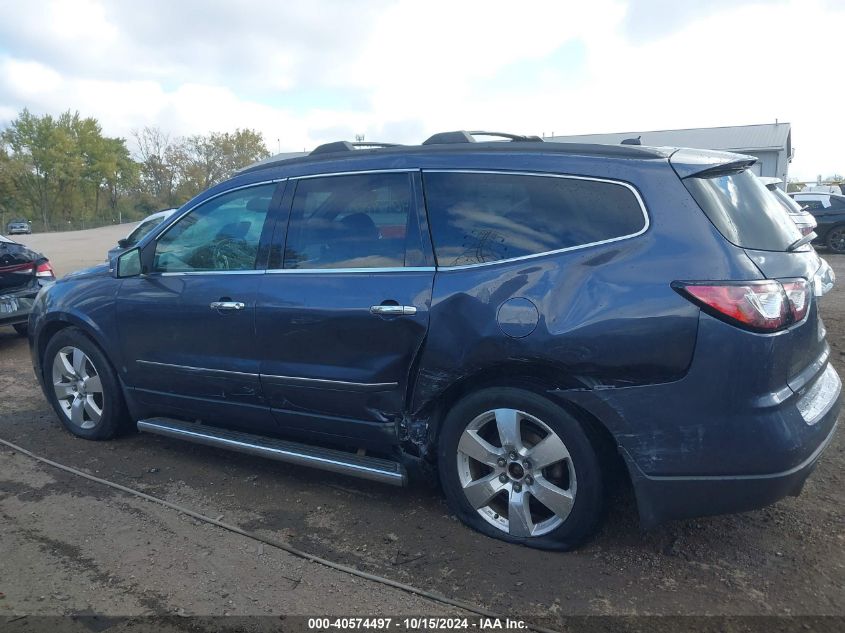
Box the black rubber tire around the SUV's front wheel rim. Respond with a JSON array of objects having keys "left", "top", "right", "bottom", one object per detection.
[{"left": 42, "top": 327, "right": 129, "bottom": 440}]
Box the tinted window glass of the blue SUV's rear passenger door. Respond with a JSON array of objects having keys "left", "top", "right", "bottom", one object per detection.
[{"left": 284, "top": 173, "right": 419, "bottom": 268}]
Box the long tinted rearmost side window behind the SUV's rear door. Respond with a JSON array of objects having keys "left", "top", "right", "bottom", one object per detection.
[{"left": 424, "top": 172, "right": 645, "bottom": 266}]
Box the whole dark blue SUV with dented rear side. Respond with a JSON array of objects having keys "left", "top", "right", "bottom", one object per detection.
[{"left": 29, "top": 132, "right": 841, "bottom": 549}]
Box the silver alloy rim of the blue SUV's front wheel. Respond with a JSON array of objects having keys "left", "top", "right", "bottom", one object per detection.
[{"left": 53, "top": 346, "right": 103, "bottom": 429}]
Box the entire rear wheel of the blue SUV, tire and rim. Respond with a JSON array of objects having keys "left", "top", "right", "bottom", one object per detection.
[{"left": 438, "top": 388, "right": 603, "bottom": 550}]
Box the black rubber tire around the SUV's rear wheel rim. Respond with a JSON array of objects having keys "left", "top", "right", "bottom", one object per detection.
[{"left": 438, "top": 387, "right": 604, "bottom": 550}]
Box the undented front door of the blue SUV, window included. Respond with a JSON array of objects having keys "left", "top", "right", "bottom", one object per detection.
[{"left": 117, "top": 183, "right": 278, "bottom": 428}]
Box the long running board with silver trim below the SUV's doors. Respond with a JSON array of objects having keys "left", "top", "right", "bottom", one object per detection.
[{"left": 138, "top": 418, "right": 408, "bottom": 486}]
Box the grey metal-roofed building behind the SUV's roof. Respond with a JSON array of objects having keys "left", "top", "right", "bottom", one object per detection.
[{"left": 545, "top": 123, "right": 792, "bottom": 183}]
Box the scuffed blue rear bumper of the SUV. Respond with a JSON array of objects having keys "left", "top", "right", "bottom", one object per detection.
[{"left": 553, "top": 307, "right": 843, "bottom": 528}]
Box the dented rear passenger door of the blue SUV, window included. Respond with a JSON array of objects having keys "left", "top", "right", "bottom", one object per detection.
[{"left": 256, "top": 171, "right": 434, "bottom": 446}]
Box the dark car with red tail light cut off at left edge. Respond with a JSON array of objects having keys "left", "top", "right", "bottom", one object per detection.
[{"left": 0, "top": 235, "right": 56, "bottom": 334}]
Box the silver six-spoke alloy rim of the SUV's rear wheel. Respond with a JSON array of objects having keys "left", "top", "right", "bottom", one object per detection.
[{"left": 457, "top": 409, "right": 576, "bottom": 537}]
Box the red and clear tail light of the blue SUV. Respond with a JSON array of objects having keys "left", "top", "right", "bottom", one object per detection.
[{"left": 672, "top": 279, "right": 810, "bottom": 332}]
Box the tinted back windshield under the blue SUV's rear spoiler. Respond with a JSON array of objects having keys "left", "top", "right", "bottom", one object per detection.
[{"left": 683, "top": 171, "right": 801, "bottom": 251}]
